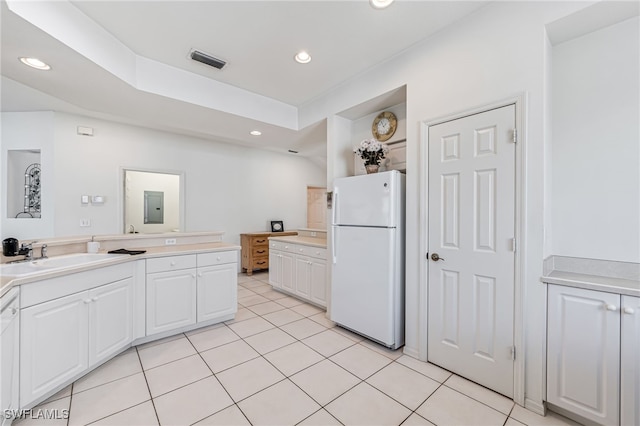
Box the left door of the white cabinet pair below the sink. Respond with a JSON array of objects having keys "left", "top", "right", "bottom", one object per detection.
[{"left": 20, "top": 291, "right": 91, "bottom": 408}]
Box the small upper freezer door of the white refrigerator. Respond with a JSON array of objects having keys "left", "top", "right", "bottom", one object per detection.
[{"left": 333, "top": 170, "right": 401, "bottom": 227}]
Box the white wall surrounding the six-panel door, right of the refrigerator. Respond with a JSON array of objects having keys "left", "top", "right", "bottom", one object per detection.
[{"left": 301, "top": 2, "right": 600, "bottom": 410}]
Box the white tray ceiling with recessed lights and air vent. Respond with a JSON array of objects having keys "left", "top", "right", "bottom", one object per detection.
[{"left": 0, "top": 0, "right": 487, "bottom": 157}]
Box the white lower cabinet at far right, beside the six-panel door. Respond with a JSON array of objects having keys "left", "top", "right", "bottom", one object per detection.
[{"left": 547, "top": 285, "right": 640, "bottom": 425}]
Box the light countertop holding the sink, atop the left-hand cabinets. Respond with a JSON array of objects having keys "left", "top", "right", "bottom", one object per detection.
[{"left": 0, "top": 242, "right": 241, "bottom": 297}]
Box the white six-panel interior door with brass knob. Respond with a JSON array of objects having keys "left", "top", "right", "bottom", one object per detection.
[{"left": 427, "top": 105, "right": 515, "bottom": 397}]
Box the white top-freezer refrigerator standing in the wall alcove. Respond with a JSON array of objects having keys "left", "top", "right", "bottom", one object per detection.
[{"left": 331, "top": 170, "right": 405, "bottom": 349}]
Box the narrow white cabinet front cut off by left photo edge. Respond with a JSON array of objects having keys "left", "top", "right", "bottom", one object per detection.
[{"left": 0, "top": 288, "right": 20, "bottom": 426}]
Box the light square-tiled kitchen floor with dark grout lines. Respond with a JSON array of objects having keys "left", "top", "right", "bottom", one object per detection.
[{"left": 16, "top": 273, "right": 576, "bottom": 426}]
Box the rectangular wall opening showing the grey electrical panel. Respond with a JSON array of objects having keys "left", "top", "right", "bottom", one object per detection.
[{"left": 123, "top": 169, "right": 184, "bottom": 234}]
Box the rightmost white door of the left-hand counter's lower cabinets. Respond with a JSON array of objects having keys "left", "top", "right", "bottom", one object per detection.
[{"left": 197, "top": 263, "right": 238, "bottom": 322}]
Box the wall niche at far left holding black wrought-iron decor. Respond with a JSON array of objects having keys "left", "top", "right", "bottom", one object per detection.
[{"left": 7, "top": 149, "right": 42, "bottom": 219}]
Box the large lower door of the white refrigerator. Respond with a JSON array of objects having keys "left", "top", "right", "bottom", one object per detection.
[{"left": 331, "top": 226, "right": 399, "bottom": 347}]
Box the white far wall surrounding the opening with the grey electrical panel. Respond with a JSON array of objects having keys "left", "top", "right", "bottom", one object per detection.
[{"left": 2, "top": 113, "right": 326, "bottom": 243}]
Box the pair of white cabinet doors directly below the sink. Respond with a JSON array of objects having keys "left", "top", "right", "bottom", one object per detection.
[{"left": 20, "top": 277, "right": 133, "bottom": 407}]
